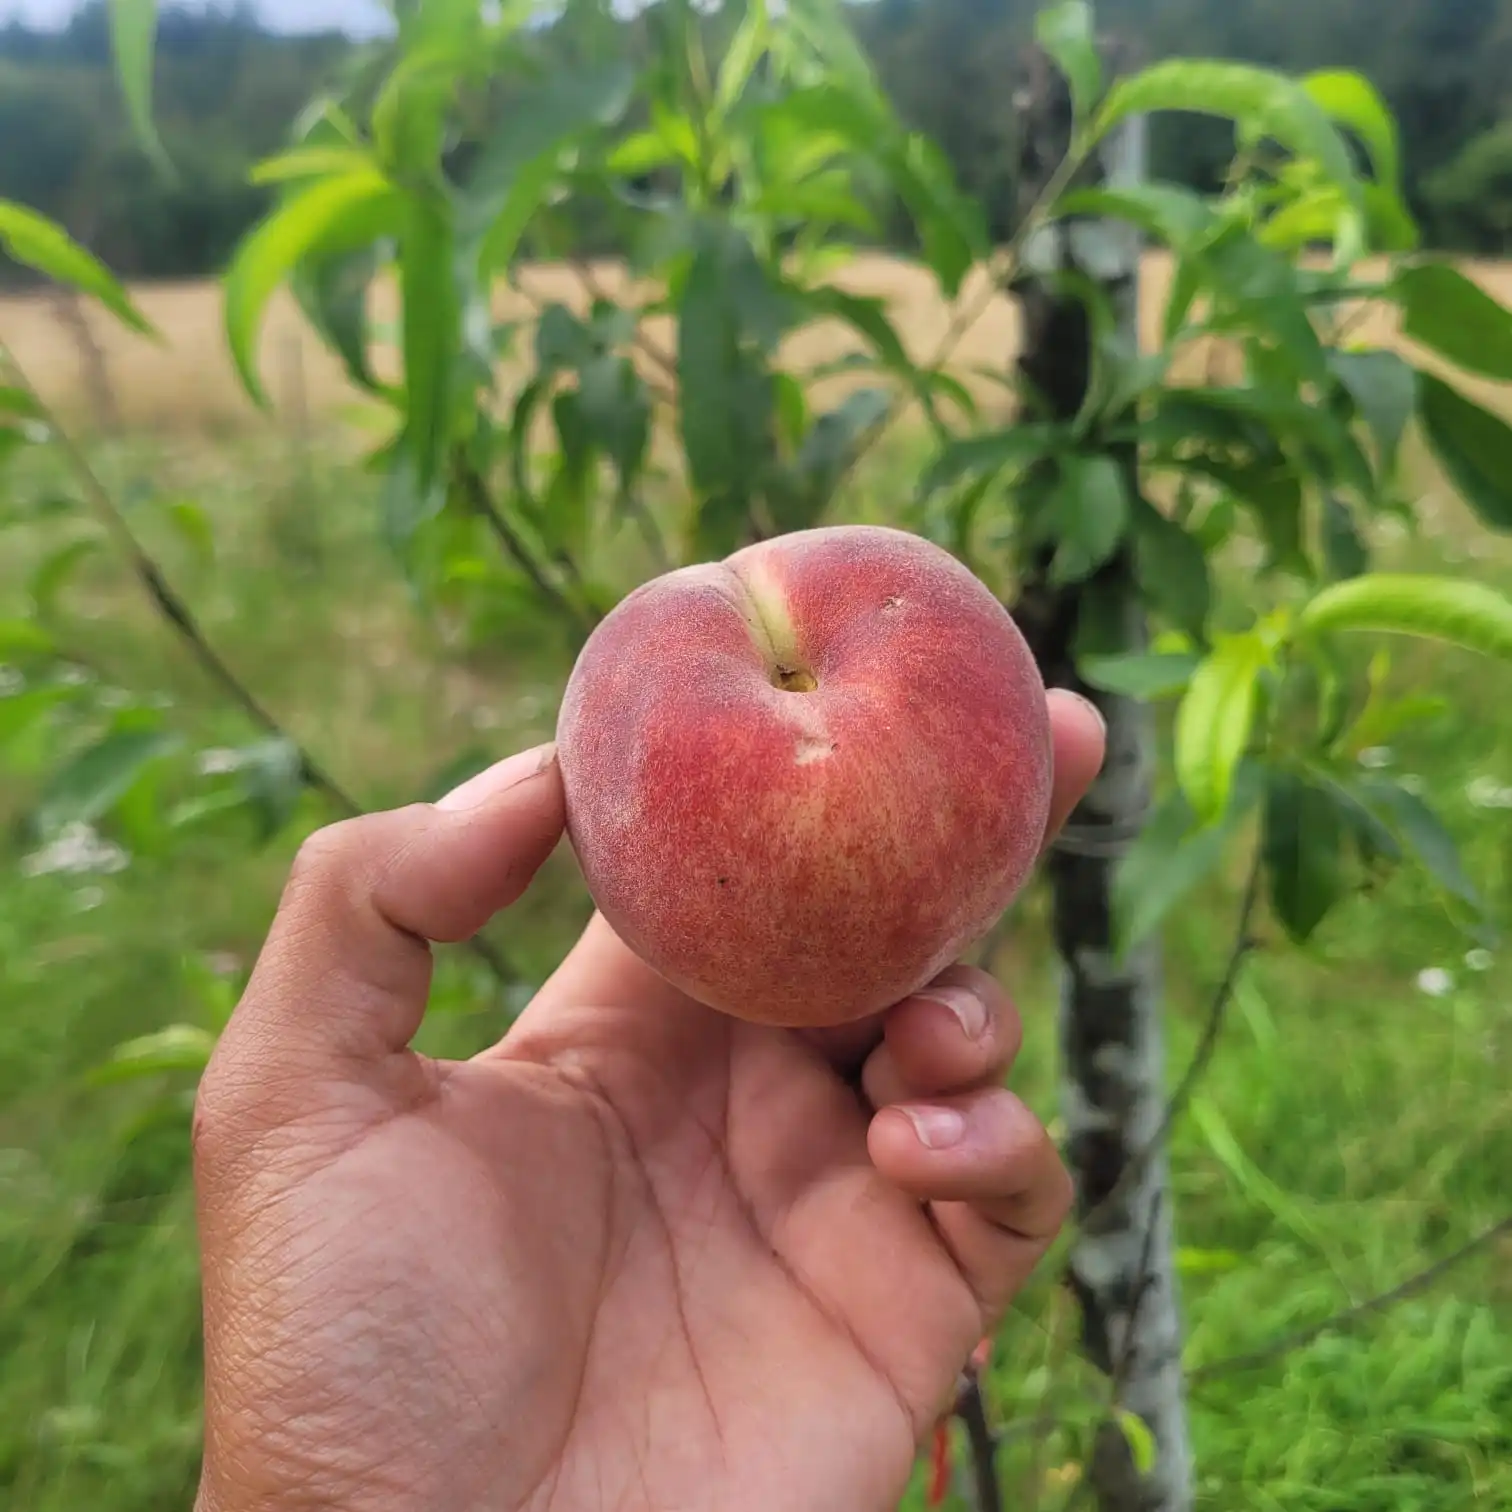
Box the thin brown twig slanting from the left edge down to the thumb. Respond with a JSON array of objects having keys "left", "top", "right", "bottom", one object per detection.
[{"left": 0, "top": 342, "right": 519, "bottom": 986}]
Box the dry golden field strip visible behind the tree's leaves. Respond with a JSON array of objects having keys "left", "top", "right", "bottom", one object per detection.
[{"left": 11, "top": 254, "right": 1512, "bottom": 434}]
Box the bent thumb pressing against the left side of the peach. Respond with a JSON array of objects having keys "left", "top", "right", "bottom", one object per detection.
[{"left": 206, "top": 745, "right": 565, "bottom": 1092}]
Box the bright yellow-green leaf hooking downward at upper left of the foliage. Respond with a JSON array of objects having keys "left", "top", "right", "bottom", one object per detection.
[{"left": 224, "top": 168, "right": 402, "bottom": 407}]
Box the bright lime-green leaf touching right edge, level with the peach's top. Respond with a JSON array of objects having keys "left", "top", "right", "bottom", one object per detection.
[{"left": 1297, "top": 573, "right": 1512, "bottom": 661}]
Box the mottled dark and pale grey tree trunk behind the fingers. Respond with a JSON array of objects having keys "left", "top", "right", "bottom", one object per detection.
[{"left": 1015, "top": 41, "right": 1193, "bottom": 1512}]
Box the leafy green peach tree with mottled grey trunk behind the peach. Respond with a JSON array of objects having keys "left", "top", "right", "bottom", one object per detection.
[{"left": 0, "top": 0, "right": 1512, "bottom": 1509}]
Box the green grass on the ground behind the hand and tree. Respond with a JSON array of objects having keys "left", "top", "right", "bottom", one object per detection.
[{"left": 0, "top": 426, "right": 1512, "bottom": 1512}]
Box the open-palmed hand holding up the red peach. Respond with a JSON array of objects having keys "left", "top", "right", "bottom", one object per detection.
[{"left": 195, "top": 694, "right": 1102, "bottom": 1512}]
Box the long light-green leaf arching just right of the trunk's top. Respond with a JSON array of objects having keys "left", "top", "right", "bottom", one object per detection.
[{"left": 1092, "top": 57, "right": 1359, "bottom": 194}]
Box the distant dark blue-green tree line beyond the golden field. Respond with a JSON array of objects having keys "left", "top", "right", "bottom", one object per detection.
[{"left": 0, "top": 0, "right": 1512, "bottom": 288}]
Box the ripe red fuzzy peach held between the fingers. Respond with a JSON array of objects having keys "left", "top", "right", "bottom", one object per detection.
[{"left": 558, "top": 526, "right": 1051, "bottom": 1027}]
